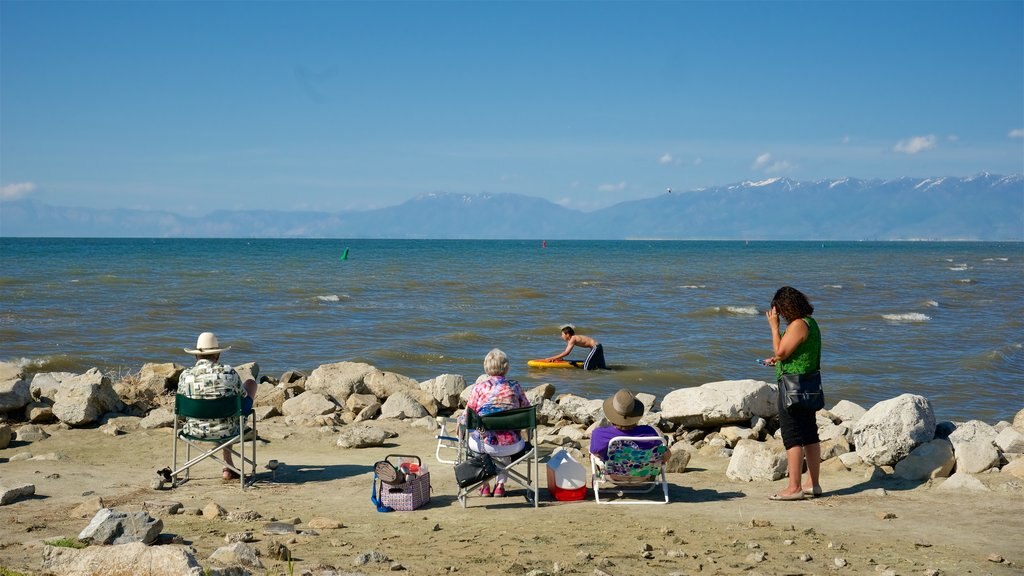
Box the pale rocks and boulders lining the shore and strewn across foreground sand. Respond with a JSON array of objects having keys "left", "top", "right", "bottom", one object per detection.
[{"left": 0, "top": 362, "right": 1024, "bottom": 575}]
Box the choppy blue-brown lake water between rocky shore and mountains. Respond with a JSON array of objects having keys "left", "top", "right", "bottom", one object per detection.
[{"left": 0, "top": 238, "right": 1024, "bottom": 423}]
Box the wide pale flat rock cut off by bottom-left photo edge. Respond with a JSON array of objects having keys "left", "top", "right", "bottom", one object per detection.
[{"left": 42, "top": 542, "right": 203, "bottom": 576}]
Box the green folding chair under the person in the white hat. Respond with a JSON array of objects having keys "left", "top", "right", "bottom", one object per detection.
[{"left": 171, "top": 394, "right": 256, "bottom": 490}]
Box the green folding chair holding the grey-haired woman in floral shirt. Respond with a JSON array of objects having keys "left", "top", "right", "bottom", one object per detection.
[{"left": 458, "top": 406, "right": 540, "bottom": 508}]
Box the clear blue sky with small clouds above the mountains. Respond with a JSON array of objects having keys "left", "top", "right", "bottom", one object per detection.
[{"left": 0, "top": 0, "right": 1024, "bottom": 214}]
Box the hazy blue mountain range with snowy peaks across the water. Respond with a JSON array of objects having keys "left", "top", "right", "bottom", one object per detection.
[{"left": 0, "top": 174, "right": 1024, "bottom": 241}]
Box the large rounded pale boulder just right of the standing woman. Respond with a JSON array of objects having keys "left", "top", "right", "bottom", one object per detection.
[{"left": 853, "top": 394, "right": 935, "bottom": 466}]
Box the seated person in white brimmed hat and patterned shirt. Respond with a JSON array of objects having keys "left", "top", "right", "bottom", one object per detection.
[{"left": 178, "top": 332, "right": 256, "bottom": 481}]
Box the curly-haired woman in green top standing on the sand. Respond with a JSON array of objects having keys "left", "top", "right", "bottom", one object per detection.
[{"left": 765, "top": 286, "right": 821, "bottom": 500}]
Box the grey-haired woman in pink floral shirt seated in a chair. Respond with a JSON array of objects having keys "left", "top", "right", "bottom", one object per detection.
[{"left": 460, "top": 348, "right": 529, "bottom": 497}]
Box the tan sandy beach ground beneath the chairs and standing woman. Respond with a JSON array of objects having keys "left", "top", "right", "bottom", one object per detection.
[{"left": 0, "top": 418, "right": 1024, "bottom": 576}]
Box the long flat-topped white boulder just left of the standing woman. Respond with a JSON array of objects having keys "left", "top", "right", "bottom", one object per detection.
[{"left": 662, "top": 380, "right": 778, "bottom": 428}]
